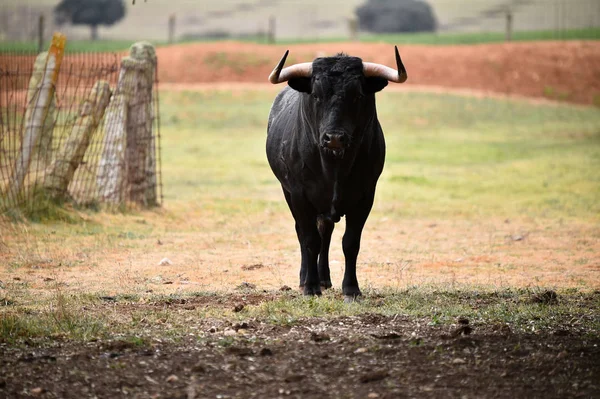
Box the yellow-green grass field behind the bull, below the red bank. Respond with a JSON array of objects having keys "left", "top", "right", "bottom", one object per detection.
[{"left": 161, "top": 88, "right": 600, "bottom": 220}]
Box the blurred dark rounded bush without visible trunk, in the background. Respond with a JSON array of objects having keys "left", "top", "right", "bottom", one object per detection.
[{"left": 356, "top": 0, "right": 437, "bottom": 33}]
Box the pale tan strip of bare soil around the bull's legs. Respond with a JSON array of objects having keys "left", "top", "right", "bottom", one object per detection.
[{"left": 0, "top": 217, "right": 600, "bottom": 296}]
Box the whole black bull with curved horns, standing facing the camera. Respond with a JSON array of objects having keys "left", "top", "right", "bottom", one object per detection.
[{"left": 267, "top": 48, "right": 407, "bottom": 300}]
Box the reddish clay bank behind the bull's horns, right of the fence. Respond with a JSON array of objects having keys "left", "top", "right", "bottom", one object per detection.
[{"left": 157, "top": 41, "right": 600, "bottom": 105}]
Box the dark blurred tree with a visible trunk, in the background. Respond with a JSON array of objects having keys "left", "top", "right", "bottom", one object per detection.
[{"left": 54, "top": 0, "right": 125, "bottom": 40}]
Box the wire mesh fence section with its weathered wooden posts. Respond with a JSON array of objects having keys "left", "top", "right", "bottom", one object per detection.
[{"left": 0, "top": 39, "right": 162, "bottom": 214}]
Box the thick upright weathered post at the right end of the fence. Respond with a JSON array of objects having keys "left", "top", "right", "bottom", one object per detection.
[{"left": 96, "top": 42, "right": 158, "bottom": 206}]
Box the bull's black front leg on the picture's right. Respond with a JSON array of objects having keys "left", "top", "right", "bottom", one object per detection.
[{"left": 342, "top": 191, "right": 375, "bottom": 301}]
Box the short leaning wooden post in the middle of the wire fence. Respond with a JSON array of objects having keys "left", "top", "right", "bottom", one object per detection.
[{"left": 44, "top": 81, "right": 111, "bottom": 200}]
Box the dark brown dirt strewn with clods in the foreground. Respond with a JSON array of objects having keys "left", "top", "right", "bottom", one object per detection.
[{"left": 0, "top": 294, "right": 600, "bottom": 399}]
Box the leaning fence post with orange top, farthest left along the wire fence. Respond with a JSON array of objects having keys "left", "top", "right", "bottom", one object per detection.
[{"left": 10, "top": 33, "right": 66, "bottom": 196}]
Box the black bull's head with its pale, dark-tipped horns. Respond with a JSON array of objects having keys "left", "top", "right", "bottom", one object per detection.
[{"left": 269, "top": 47, "right": 407, "bottom": 157}]
